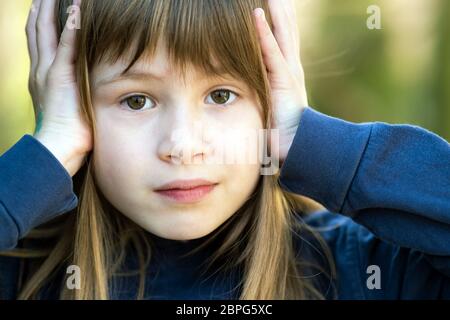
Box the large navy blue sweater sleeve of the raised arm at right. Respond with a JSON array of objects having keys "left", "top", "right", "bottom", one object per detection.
[{"left": 280, "top": 108, "right": 450, "bottom": 258}]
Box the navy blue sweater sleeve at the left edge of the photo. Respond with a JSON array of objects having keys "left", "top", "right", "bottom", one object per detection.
[{"left": 0, "top": 135, "right": 78, "bottom": 250}]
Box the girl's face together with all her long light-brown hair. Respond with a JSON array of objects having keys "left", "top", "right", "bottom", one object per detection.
[{"left": 14, "top": 0, "right": 332, "bottom": 299}]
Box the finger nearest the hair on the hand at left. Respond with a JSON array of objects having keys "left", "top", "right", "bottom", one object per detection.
[{"left": 53, "top": 4, "right": 79, "bottom": 68}]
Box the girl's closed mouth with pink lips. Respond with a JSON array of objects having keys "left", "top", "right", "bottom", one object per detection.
[{"left": 155, "top": 179, "right": 218, "bottom": 204}]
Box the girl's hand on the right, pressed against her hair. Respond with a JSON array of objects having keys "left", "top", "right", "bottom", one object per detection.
[{"left": 254, "top": 0, "right": 308, "bottom": 161}]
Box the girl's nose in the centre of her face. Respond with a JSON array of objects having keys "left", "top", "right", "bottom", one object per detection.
[{"left": 158, "top": 105, "right": 210, "bottom": 165}]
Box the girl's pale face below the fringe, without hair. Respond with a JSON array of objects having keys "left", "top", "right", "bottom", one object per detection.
[{"left": 91, "top": 40, "right": 263, "bottom": 240}]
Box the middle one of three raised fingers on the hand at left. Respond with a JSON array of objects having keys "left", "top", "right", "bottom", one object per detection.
[{"left": 36, "top": 0, "right": 58, "bottom": 70}]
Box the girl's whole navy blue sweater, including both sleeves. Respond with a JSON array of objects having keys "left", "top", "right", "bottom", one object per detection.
[{"left": 0, "top": 108, "right": 450, "bottom": 299}]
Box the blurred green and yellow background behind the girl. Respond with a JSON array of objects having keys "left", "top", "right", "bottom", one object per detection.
[{"left": 0, "top": 0, "right": 450, "bottom": 154}]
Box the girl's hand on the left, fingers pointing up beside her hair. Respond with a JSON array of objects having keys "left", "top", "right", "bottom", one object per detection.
[{"left": 26, "top": 0, "right": 93, "bottom": 177}]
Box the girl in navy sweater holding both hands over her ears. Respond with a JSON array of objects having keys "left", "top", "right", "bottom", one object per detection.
[{"left": 0, "top": 0, "right": 450, "bottom": 299}]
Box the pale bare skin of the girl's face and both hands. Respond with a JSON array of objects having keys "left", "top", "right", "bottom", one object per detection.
[{"left": 26, "top": 0, "right": 308, "bottom": 240}]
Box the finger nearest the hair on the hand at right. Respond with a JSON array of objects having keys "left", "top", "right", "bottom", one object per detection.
[{"left": 254, "top": 8, "right": 286, "bottom": 73}]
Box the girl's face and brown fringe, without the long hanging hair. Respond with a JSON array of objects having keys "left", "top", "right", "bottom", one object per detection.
[{"left": 80, "top": 0, "right": 268, "bottom": 240}]
